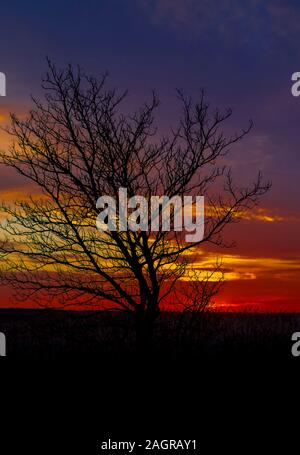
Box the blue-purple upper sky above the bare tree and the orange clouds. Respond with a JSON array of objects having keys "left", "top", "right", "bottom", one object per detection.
[{"left": 0, "top": 0, "right": 300, "bottom": 235}]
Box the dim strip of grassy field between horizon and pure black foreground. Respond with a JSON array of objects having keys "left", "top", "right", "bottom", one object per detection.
[{"left": 0, "top": 309, "right": 300, "bottom": 363}]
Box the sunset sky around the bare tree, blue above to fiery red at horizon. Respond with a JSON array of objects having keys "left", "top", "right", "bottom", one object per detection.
[{"left": 0, "top": 0, "right": 300, "bottom": 311}]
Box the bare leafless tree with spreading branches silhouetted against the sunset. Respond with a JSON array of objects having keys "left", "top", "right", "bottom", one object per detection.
[{"left": 0, "top": 62, "right": 270, "bottom": 347}]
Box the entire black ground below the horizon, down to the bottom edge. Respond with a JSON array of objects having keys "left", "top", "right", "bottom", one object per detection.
[{"left": 0, "top": 310, "right": 300, "bottom": 455}]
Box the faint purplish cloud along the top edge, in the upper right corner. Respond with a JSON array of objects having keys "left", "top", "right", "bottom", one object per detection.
[{"left": 138, "top": 0, "right": 300, "bottom": 47}]
